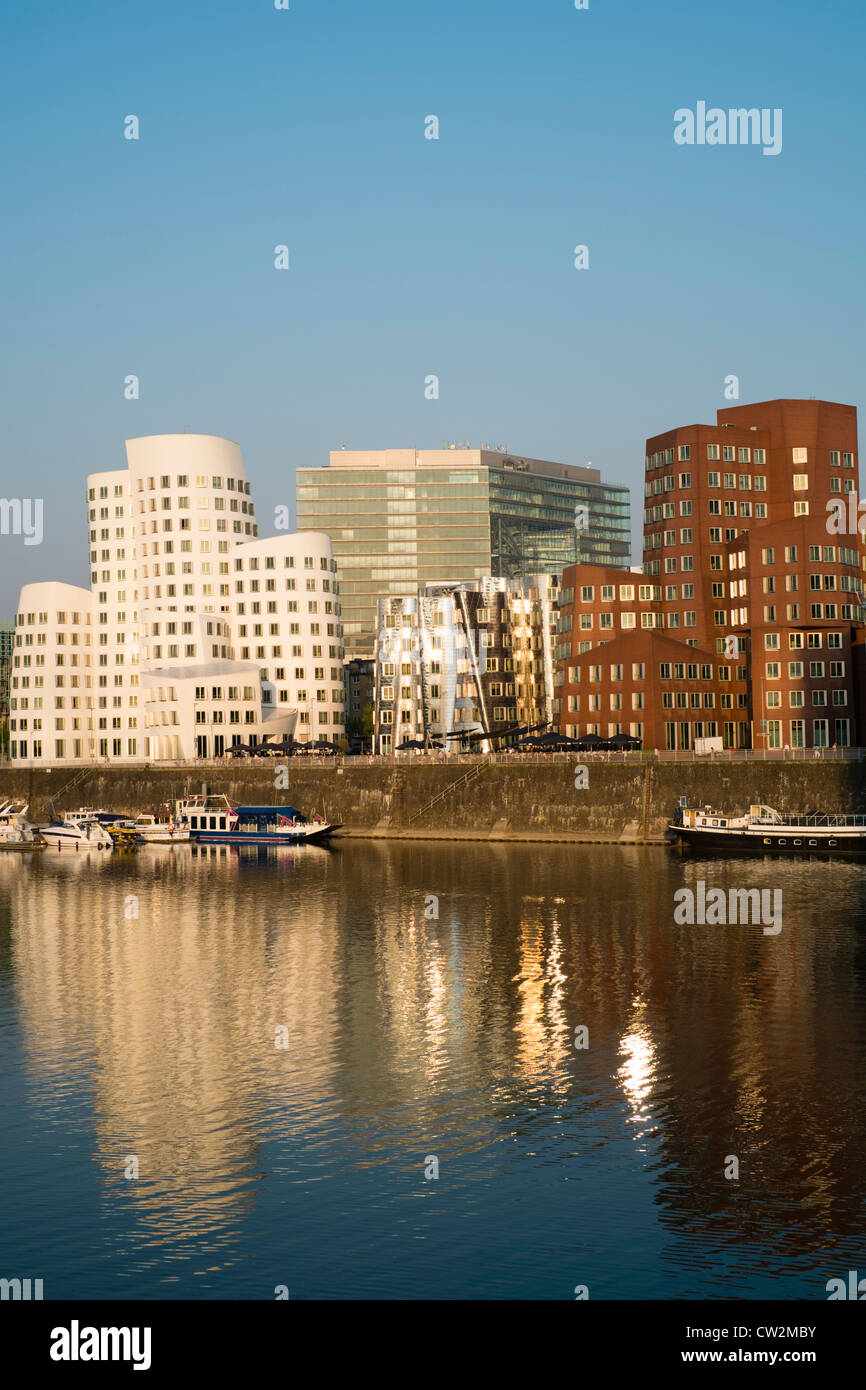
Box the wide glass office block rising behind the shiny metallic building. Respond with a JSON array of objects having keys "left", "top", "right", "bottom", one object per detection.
[{"left": 297, "top": 449, "right": 631, "bottom": 657}]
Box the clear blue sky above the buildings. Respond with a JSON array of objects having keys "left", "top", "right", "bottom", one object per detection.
[{"left": 0, "top": 0, "right": 866, "bottom": 597}]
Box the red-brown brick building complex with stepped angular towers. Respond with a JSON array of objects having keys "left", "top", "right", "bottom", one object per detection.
[{"left": 559, "top": 400, "right": 866, "bottom": 749}]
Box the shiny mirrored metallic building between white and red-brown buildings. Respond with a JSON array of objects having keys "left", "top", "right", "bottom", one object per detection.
[{"left": 374, "top": 574, "right": 559, "bottom": 752}]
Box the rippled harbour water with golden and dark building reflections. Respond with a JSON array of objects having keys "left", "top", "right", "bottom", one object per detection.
[{"left": 0, "top": 841, "right": 866, "bottom": 1297}]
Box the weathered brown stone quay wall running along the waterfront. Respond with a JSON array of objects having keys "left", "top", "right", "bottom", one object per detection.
[{"left": 0, "top": 758, "right": 866, "bottom": 842}]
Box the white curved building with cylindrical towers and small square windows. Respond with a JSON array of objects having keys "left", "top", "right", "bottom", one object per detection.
[{"left": 10, "top": 435, "right": 345, "bottom": 765}]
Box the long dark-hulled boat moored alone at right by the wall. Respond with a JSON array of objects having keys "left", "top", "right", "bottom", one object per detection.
[{"left": 669, "top": 805, "right": 866, "bottom": 855}]
